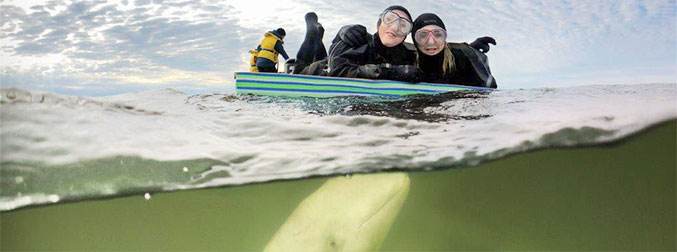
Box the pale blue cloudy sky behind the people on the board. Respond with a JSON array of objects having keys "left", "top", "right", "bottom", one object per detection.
[{"left": 0, "top": 0, "right": 677, "bottom": 95}]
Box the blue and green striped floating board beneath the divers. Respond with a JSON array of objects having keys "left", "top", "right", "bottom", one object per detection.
[{"left": 235, "top": 72, "right": 491, "bottom": 97}]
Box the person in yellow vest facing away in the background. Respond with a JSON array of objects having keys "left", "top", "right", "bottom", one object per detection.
[{"left": 256, "top": 28, "right": 289, "bottom": 73}]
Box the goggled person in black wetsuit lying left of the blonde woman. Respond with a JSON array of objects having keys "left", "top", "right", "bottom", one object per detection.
[{"left": 294, "top": 5, "right": 421, "bottom": 82}]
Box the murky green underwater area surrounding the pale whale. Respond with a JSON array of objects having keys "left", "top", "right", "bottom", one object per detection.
[{"left": 0, "top": 121, "right": 677, "bottom": 251}]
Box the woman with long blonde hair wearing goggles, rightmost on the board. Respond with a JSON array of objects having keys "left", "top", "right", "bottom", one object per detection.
[{"left": 412, "top": 13, "right": 496, "bottom": 88}]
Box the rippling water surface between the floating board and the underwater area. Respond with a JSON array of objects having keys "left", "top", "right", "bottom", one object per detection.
[{"left": 0, "top": 84, "right": 677, "bottom": 211}]
